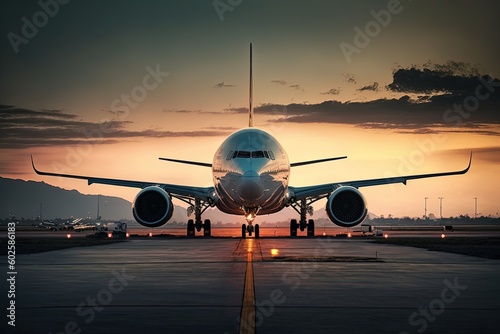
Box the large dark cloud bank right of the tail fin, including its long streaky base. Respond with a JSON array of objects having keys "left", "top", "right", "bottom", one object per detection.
[{"left": 255, "top": 62, "right": 500, "bottom": 136}]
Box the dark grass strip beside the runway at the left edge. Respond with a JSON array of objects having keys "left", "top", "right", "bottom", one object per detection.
[{"left": 0, "top": 238, "right": 125, "bottom": 255}]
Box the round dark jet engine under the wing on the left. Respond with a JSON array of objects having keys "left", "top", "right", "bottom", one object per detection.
[{"left": 132, "top": 186, "right": 174, "bottom": 227}]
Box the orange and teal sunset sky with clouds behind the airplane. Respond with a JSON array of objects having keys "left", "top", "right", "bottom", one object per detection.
[{"left": 0, "top": 0, "right": 500, "bottom": 217}]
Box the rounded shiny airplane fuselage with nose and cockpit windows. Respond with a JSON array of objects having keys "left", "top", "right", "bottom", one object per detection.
[{"left": 212, "top": 128, "right": 290, "bottom": 221}]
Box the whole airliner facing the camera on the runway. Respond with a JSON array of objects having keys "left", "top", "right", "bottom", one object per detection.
[{"left": 31, "top": 43, "right": 472, "bottom": 238}]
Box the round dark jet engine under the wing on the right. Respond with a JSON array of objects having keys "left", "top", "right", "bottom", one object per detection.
[{"left": 326, "top": 186, "right": 368, "bottom": 227}]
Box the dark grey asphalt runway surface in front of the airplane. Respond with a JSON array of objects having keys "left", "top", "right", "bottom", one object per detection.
[{"left": 2, "top": 238, "right": 500, "bottom": 334}]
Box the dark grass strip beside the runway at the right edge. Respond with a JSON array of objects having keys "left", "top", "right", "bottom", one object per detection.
[{"left": 373, "top": 237, "right": 500, "bottom": 260}]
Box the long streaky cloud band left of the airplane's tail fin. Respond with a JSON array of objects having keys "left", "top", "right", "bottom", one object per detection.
[{"left": 0, "top": 105, "right": 228, "bottom": 149}]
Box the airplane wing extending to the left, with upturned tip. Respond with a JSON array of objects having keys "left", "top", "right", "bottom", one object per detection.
[{"left": 31, "top": 156, "right": 214, "bottom": 201}]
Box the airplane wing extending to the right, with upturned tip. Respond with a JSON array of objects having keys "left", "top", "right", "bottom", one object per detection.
[{"left": 289, "top": 152, "right": 472, "bottom": 200}]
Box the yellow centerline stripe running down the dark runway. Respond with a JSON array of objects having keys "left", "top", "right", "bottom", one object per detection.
[{"left": 240, "top": 251, "right": 255, "bottom": 334}]
